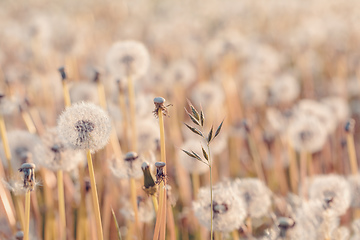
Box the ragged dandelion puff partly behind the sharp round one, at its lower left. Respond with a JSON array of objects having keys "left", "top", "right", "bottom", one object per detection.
[{"left": 34, "top": 128, "right": 85, "bottom": 171}]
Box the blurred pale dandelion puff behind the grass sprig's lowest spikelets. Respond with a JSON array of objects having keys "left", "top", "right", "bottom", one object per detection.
[{"left": 178, "top": 138, "right": 209, "bottom": 174}]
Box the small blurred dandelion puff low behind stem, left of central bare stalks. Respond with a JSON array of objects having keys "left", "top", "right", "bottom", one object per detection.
[{"left": 120, "top": 197, "right": 155, "bottom": 223}]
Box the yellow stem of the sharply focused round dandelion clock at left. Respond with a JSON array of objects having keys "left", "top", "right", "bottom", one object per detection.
[{"left": 86, "top": 149, "right": 103, "bottom": 240}]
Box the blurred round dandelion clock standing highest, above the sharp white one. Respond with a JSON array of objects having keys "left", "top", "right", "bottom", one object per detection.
[{"left": 106, "top": 41, "right": 150, "bottom": 79}]
